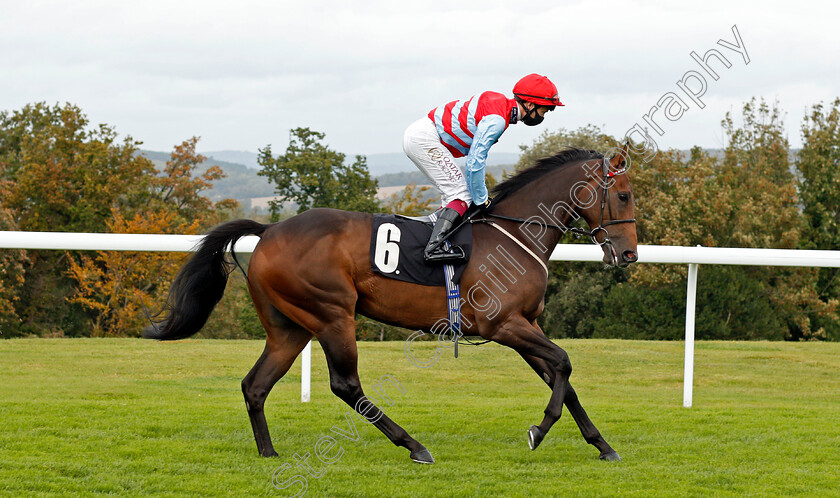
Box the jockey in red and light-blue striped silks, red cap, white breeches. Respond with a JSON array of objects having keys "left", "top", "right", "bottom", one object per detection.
[{"left": 403, "top": 74, "right": 563, "bottom": 263}]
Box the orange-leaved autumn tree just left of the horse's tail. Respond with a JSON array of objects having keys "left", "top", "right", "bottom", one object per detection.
[{"left": 69, "top": 137, "right": 238, "bottom": 336}]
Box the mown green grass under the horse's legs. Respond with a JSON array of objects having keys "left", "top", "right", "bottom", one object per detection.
[{"left": 0, "top": 339, "right": 840, "bottom": 497}]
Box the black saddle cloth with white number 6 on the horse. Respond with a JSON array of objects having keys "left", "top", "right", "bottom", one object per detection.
[{"left": 370, "top": 214, "right": 472, "bottom": 287}]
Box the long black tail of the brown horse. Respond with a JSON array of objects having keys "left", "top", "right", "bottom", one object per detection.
[{"left": 143, "top": 220, "right": 268, "bottom": 341}]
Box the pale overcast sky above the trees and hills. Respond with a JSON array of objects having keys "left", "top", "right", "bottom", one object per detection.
[{"left": 0, "top": 0, "right": 840, "bottom": 158}]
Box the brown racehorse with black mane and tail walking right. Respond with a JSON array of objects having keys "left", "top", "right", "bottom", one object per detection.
[{"left": 144, "top": 145, "right": 637, "bottom": 464}]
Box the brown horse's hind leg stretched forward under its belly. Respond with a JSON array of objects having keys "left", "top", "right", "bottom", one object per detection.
[{"left": 318, "top": 317, "right": 435, "bottom": 463}]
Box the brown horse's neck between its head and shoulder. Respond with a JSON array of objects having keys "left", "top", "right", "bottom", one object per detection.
[{"left": 496, "top": 166, "right": 586, "bottom": 259}]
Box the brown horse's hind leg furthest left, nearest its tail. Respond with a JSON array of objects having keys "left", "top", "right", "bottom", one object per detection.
[{"left": 242, "top": 309, "right": 312, "bottom": 457}]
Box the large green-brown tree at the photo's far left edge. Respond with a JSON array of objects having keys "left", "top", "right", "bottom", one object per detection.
[{"left": 0, "top": 103, "right": 154, "bottom": 335}]
